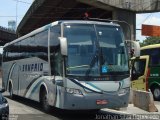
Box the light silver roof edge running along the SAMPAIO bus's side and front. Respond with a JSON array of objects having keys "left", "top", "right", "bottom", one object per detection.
[{"left": 4, "top": 20, "right": 120, "bottom": 47}]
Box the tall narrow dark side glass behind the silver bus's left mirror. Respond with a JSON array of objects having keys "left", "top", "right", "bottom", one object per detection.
[{"left": 50, "top": 25, "right": 62, "bottom": 75}]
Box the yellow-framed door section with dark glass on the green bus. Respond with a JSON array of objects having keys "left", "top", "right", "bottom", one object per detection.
[{"left": 131, "top": 55, "right": 149, "bottom": 91}]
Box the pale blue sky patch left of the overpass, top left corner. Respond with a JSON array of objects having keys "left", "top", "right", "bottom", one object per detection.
[{"left": 0, "top": 0, "right": 34, "bottom": 27}]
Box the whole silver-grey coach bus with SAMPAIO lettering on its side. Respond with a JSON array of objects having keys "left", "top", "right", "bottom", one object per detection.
[{"left": 2, "top": 20, "right": 139, "bottom": 111}]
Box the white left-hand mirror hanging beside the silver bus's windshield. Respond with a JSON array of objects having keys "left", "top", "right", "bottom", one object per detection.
[{"left": 59, "top": 37, "right": 68, "bottom": 56}]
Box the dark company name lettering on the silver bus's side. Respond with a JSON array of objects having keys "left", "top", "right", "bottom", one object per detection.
[{"left": 22, "top": 63, "right": 43, "bottom": 72}]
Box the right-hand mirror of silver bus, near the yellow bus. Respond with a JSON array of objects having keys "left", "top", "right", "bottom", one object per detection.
[{"left": 126, "top": 40, "right": 140, "bottom": 57}]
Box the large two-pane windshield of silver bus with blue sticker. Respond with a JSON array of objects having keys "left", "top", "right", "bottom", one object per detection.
[{"left": 64, "top": 24, "right": 129, "bottom": 76}]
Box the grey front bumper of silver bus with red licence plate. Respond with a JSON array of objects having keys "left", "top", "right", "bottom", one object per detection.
[{"left": 59, "top": 92, "right": 129, "bottom": 110}]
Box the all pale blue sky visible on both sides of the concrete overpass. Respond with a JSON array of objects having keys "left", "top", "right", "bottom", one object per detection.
[{"left": 0, "top": 0, "right": 160, "bottom": 42}]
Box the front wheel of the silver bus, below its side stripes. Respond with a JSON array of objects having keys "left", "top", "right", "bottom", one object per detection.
[{"left": 40, "top": 90, "right": 50, "bottom": 113}]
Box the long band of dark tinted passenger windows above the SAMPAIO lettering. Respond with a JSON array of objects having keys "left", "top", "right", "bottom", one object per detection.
[{"left": 3, "top": 31, "right": 48, "bottom": 62}]
